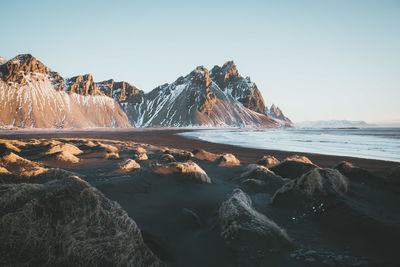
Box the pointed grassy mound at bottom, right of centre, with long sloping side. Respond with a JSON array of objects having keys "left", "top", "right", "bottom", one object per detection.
[{"left": 218, "top": 189, "right": 292, "bottom": 264}]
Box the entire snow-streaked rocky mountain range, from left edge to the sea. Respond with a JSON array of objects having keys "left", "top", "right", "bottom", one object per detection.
[{"left": 0, "top": 54, "right": 293, "bottom": 128}]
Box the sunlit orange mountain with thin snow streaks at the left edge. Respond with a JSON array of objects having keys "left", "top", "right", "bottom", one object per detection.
[{"left": 0, "top": 54, "right": 130, "bottom": 128}]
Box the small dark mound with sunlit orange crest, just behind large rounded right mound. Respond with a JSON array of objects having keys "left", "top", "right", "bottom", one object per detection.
[{"left": 269, "top": 157, "right": 318, "bottom": 179}]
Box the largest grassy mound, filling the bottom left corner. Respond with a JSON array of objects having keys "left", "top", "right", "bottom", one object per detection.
[{"left": 0, "top": 171, "right": 163, "bottom": 266}]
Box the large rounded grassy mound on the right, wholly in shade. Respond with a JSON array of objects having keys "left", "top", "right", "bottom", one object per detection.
[{"left": 271, "top": 168, "right": 348, "bottom": 208}]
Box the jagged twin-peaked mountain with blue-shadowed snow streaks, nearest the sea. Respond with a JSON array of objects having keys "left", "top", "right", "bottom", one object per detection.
[{"left": 104, "top": 61, "right": 288, "bottom": 127}]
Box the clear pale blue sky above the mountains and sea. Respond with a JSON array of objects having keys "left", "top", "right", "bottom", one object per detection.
[{"left": 0, "top": 0, "right": 400, "bottom": 122}]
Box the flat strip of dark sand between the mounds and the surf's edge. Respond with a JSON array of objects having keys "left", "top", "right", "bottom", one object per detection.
[{"left": 0, "top": 128, "right": 399, "bottom": 172}]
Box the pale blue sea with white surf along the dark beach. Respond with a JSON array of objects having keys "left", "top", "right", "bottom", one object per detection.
[{"left": 180, "top": 127, "right": 400, "bottom": 162}]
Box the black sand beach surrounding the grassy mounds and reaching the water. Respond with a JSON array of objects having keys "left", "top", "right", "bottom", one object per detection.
[{"left": 0, "top": 129, "right": 400, "bottom": 266}]
